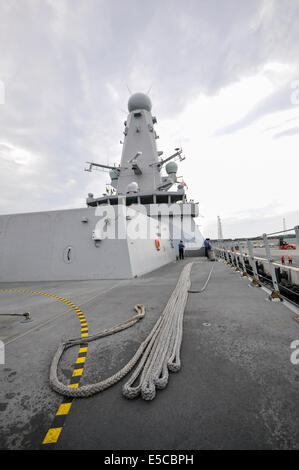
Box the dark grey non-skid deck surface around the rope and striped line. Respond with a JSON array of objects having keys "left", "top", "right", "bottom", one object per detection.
[{"left": 0, "top": 258, "right": 299, "bottom": 450}]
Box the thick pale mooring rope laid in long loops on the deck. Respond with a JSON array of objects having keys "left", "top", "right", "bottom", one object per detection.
[{"left": 50, "top": 262, "right": 194, "bottom": 400}]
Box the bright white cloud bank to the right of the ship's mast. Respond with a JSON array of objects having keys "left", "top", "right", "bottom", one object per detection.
[{"left": 159, "top": 67, "right": 299, "bottom": 237}]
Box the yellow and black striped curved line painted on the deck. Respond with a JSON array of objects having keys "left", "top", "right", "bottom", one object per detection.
[{"left": 0, "top": 289, "right": 88, "bottom": 446}]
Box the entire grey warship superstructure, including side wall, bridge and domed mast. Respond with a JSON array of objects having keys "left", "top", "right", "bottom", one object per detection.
[{"left": 0, "top": 93, "right": 203, "bottom": 282}]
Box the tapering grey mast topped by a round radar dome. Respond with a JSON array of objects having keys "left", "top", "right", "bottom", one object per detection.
[{"left": 87, "top": 93, "right": 185, "bottom": 205}]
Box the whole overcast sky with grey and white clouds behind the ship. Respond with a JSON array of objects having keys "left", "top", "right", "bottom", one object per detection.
[{"left": 0, "top": 0, "right": 299, "bottom": 237}]
